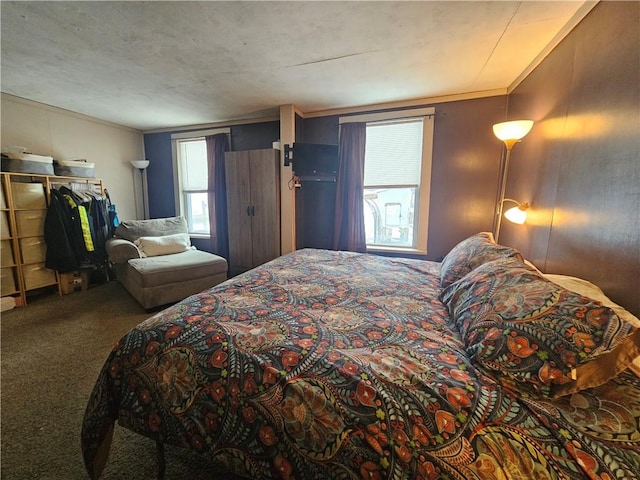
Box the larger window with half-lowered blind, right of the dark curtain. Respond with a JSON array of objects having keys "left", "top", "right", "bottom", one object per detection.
[{"left": 340, "top": 108, "right": 434, "bottom": 253}]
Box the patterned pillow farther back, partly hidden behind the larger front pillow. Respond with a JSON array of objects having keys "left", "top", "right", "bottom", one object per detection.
[{"left": 440, "top": 232, "right": 524, "bottom": 288}]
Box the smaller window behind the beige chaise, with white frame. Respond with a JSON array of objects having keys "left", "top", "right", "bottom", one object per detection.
[{"left": 171, "top": 125, "right": 229, "bottom": 237}]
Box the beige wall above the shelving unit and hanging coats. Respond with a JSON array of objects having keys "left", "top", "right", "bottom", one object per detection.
[{"left": 1, "top": 94, "right": 144, "bottom": 218}]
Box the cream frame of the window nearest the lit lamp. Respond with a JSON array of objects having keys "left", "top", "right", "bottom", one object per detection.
[{"left": 339, "top": 107, "right": 435, "bottom": 255}]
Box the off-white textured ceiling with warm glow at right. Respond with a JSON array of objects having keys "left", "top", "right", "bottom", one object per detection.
[{"left": 1, "top": 1, "right": 595, "bottom": 130}]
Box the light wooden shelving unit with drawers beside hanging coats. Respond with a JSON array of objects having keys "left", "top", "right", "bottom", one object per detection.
[{"left": 0, "top": 172, "right": 104, "bottom": 306}]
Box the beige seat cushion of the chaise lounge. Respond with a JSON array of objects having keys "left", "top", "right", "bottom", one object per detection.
[{"left": 129, "top": 250, "right": 227, "bottom": 288}]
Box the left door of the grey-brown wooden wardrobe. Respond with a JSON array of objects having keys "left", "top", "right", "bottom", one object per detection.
[{"left": 225, "top": 151, "right": 253, "bottom": 275}]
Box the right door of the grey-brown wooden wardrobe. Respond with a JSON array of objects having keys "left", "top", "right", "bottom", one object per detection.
[{"left": 250, "top": 149, "right": 280, "bottom": 266}]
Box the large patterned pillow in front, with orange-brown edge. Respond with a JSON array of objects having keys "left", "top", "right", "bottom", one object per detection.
[{"left": 442, "top": 259, "right": 640, "bottom": 398}]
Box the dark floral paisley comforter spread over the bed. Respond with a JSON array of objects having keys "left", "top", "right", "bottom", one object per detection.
[{"left": 82, "top": 249, "right": 640, "bottom": 480}]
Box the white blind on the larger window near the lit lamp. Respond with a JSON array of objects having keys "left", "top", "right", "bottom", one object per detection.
[{"left": 364, "top": 118, "right": 423, "bottom": 187}]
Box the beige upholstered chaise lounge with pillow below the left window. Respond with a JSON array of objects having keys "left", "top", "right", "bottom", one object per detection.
[{"left": 106, "top": 217, "right": 227, "bottom": 309}]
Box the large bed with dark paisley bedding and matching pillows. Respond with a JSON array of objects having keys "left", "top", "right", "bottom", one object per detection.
[{"left": 82, "top": 232, "right": 640, "bottom": 480}]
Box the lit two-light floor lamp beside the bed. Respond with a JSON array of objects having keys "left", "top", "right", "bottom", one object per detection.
[{"left": 493, "top": 120, "right": 533, "bottom": 242}]
